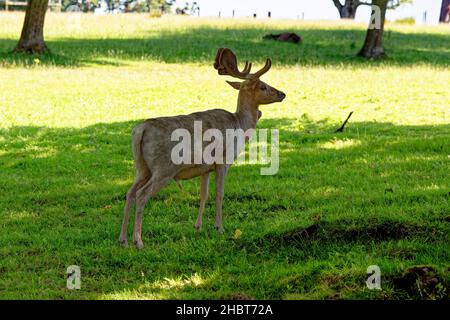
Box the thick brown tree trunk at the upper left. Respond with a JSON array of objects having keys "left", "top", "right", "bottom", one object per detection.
[{"left": 14, "top": 0, "right": 48, "bottom": 53}]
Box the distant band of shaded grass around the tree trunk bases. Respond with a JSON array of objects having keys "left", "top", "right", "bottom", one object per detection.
[{"left": 0, "top": 27, "right": 450, "bottom": 67}]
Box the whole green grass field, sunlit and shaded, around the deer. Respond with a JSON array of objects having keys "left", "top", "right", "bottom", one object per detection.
[{"left": 0, "top": 13, "right": 450, "bottom": 299}]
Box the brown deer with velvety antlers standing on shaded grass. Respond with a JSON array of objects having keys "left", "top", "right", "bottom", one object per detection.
[{"left": 119, "top": 48, "right": 286, "bottom": 249}]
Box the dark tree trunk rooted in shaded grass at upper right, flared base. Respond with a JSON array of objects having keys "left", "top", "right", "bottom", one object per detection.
[{"left": 358, "top": 0, "right": 388, "bottom": 58}]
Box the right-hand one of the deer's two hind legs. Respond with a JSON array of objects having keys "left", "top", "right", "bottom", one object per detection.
[{"left": 133, "top": 174, "right": 173, "bottom": 249}]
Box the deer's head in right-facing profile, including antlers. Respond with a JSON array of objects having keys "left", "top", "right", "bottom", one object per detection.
[{"left": 214, "top": 48, "right": 286, "bottom": 106}]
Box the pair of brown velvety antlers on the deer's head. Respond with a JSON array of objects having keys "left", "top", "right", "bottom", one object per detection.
[{"left": 214, "top": 48, "right": 272, "bottom": 80}]
